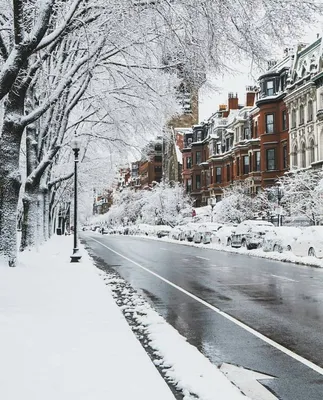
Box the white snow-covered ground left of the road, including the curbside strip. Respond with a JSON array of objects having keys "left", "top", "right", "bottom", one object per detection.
[{"left": 0, "top": 236, "right": 247, "bottom": 400}]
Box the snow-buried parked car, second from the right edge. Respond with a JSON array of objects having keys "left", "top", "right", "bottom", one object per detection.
[{"left": 262, "top": 226, "right": 302, "bottom": 253}]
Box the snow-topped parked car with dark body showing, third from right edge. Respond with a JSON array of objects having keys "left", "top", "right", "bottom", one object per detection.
[{"left": 231, "top": 220, "right": 274, "bottom": 250}]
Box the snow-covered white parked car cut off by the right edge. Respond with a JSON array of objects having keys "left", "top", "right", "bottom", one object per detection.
[{"left": 290, "top": 226, "right": 323, "bottom": 258}]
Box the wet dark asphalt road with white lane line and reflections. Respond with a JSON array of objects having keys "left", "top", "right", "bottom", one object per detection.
[{"left": 82, "top": 232, "right": 323, "bottom": 400}]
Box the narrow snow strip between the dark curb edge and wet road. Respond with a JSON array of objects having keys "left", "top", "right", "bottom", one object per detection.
[{"left": 102, "top": 266, "right": 248, "bottom": 400}]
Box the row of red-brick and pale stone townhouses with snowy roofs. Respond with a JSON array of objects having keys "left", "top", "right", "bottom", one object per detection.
[{"left": 182, "top": 38, "right": 323, "bottom": 207}]
